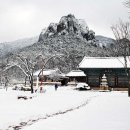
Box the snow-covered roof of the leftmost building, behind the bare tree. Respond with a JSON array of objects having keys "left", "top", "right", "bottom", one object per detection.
[{"left": 33, "top": 68, "right": 62, "bottom": 76}]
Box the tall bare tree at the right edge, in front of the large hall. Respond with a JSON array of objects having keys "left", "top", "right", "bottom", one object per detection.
[{"left": 111, "top": 20, "right": 130, "bottom": 96}]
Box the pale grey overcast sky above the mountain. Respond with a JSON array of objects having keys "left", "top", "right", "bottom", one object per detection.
[{"left": 0, "top": 0, "right": 130, "bottom": 42}]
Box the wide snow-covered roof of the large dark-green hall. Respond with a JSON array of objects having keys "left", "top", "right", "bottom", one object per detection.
[{"left": 79, "top": 56, "right": 130, "bottom": 68}]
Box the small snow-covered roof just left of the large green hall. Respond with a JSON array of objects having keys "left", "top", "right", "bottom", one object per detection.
[{"left": 66, "top": 70, "right": 86, "bottom": 77}]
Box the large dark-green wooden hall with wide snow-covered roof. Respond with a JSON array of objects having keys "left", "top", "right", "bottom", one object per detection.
[{"left": 79, "top": 57, "right": 130, "bottom": 88}]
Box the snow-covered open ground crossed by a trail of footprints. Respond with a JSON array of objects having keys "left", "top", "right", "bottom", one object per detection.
[{"left": 0, "top": 86, "right": 130, "bottom": 130}]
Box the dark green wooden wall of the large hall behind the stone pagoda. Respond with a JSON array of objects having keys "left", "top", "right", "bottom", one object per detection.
[{"left": 81, "top": 68, "right": 129, "bottom": 88}]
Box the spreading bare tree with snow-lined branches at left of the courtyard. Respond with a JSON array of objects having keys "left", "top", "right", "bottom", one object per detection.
[{"left": 3, "top": 51, "right": 66, "bottom": 93}]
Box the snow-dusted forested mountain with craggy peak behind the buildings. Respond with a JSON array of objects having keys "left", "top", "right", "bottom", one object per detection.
[{"left": 0, "top": 14, "right": 114, "bottom": 81}]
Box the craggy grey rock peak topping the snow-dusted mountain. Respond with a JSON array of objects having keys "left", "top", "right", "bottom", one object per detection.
[{"left": 39, "top": 14, "right": 95, "bottom": 41}]
